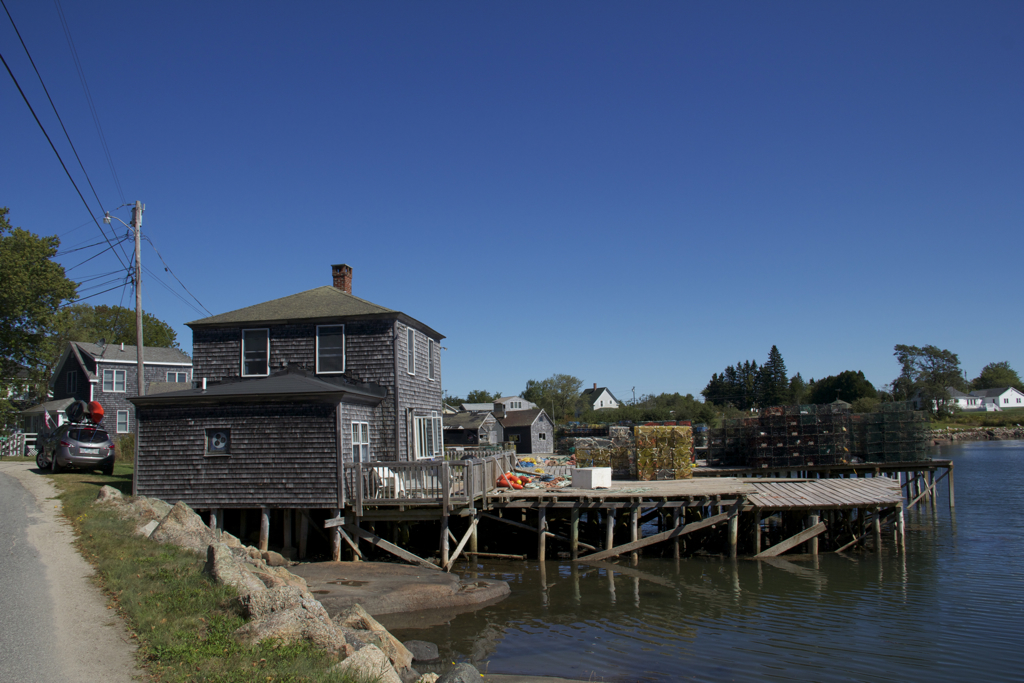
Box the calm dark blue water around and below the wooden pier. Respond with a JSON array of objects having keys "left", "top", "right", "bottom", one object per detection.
[{"left": 395, "top": 441, "right": 1024, "bottom": 681}]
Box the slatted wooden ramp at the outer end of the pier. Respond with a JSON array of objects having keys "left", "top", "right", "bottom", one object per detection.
[{"left": 746, "top": 477, "right": 903, "bottom": 510}]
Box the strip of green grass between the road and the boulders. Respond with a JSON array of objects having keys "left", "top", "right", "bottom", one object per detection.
[{"left": 44, "top": 463, "right": 368, "bottom": 683}]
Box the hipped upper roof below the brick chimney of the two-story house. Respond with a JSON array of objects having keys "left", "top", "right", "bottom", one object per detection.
[{"left": 185, "top": 286, "right": 444, "bottom": 339}]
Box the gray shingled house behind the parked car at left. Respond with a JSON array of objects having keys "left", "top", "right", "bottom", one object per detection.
[{"left": 41, "top": 342, "right": 193, "bottom": 434}]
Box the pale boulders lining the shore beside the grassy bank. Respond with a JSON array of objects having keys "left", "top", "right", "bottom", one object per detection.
[{"left": 96, "top": 486, "right": 495, "bottom": 683}]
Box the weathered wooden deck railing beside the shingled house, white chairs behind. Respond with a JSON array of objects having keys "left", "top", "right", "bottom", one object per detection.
[{"left": 346, "top": 451, "right": 516, "bottom": 514}]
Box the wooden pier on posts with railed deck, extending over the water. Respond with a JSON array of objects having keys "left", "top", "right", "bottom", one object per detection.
[{"left": 325, "top": 453, "right": 953, "bottom": 570}]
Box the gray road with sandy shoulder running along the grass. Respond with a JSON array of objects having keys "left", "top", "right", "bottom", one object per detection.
[{"left": 0, "top": 462, "right": 137, "bottom": 683}]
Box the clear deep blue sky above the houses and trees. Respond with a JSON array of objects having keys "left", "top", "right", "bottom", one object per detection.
[{"left": 0, "top": 0, "right": 1024, "bottom": 398}]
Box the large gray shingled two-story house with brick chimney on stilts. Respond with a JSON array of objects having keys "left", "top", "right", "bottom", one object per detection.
[{"left": 133, "top": 264, "right": 443, "bottom": 552}]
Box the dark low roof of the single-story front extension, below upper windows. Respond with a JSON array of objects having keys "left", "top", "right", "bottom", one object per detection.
[{"left": 128, "top": 368, "right": 387, "bottom": 405}]
